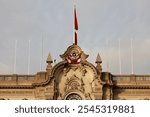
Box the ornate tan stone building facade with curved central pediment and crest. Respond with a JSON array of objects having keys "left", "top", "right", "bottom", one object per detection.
[{"left": 0, "top": 44, "right": 150, "bottom": 100}]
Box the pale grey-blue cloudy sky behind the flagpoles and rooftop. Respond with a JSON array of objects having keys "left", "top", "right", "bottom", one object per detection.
[{"left": 0, "top": 0, "right": 150, "bottom": 74}]
